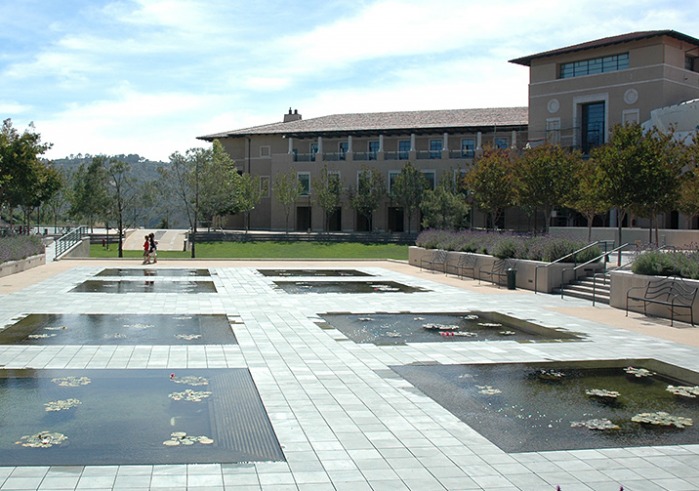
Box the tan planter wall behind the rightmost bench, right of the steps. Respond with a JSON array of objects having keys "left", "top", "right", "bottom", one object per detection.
[{"left": 609, "top": 271, "right": 699, "bottom": 322}]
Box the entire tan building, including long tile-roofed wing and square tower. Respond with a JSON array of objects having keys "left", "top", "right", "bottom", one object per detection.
[{"left": 199, "top": 30, "right": 699, "bottom": 232}]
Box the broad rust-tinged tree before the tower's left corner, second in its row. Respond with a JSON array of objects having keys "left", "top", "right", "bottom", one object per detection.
[{"left": 513, "top": 144, "right": 582, "bottom": 233}]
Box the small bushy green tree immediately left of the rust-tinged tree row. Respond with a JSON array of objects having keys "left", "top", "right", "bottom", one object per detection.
[{"left": 420, "top": 175, "right": 470, "bottom": 230}]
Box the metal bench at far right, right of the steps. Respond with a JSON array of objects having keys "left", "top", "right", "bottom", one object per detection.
[{"left": 626, "top": 277, "right": 699, "bottom": 326}]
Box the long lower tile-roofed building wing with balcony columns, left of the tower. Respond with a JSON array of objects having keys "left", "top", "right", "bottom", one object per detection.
[{"left": 199, "top": 107, "right": 527, "bottom": 232}]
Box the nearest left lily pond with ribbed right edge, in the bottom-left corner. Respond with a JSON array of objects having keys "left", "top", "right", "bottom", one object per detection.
[{"left": 0, "top": 368, "right": 284, "bottom": 466}]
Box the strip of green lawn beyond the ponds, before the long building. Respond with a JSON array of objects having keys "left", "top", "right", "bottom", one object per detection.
[{"left": 90, "top": 241, "right": 408, "bottom": 261}]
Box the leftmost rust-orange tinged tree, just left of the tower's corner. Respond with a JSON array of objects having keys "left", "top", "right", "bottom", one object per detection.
[{"left": 465, "top": 147, "right": 515, "bottom": 232}]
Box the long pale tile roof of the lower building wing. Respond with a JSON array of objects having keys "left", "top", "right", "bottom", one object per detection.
[{"left": 198, "top": 107, "right": 528, "bottom": 141}]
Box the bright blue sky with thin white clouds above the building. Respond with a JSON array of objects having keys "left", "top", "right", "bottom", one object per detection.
[{"left": 0, "top": 0, "right": 699, "bottom": 161}]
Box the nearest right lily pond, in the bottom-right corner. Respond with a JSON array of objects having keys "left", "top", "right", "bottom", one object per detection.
[{"left": 391, "top": 360, "right": 699, "bottom": 452}]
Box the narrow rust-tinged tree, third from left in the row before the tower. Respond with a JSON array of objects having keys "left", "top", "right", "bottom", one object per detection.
[{"left": 565, "top": 159, "right": 610, "bottom": 242}]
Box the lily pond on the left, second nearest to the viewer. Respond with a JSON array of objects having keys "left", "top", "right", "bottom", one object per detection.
[{"left": 0, "top": 314, "right": 237, "bottom": 345}]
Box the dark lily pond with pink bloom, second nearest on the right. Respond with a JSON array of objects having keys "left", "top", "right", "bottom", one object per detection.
[{"left": 319, "top": 312, "right": 581, "bottom": 345}]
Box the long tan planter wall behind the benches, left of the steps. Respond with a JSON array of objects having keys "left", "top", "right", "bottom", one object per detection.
[{"left": 408, "top": 246, "right": 604, "bottom": 293}]
